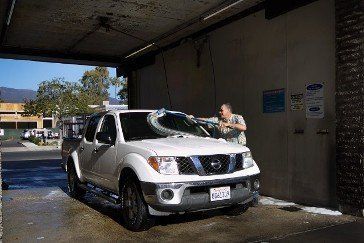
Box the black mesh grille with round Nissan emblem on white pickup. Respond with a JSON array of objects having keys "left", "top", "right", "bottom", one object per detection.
[{"left": 176, "top": 154, "right": 243, "bottom": 176}]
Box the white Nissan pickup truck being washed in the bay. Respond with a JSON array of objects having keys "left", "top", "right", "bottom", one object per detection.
[{"left": 62, "top": 110, "right": 260, "bottom": 231}]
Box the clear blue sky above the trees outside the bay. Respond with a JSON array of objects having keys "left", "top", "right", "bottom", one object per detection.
[{"left": 0, "top": 58, "right": 120, "bottom": 97}]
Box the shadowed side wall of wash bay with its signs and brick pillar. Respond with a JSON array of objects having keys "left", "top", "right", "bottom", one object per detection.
[{"left": 121, "top": 1, "right": 363, "bottom": 215}]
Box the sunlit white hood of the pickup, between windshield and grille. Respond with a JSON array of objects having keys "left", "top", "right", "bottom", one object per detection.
[{"left": 129, "top": 137, "right": 249, "bottom": 156}]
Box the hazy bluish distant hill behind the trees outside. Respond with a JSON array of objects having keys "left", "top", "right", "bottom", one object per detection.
[{"left": 0, "top": 87, "right": 119, "bottom": 105}]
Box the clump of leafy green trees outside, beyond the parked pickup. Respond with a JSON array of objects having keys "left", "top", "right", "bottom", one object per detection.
[{"left": 24, "top": 67, "right": 120, "bottom": 121}]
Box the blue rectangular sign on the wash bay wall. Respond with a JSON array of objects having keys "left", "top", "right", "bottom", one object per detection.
[{"left": 263, "top": 89, "right": 286, "bottom": 113}]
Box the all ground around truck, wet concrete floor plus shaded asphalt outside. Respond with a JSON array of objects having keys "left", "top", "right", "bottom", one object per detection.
[{"left": 2, "top": 142, "right": 364, "bottom": 242}]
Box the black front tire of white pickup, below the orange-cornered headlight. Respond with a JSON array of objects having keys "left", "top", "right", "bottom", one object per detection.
[{"left": 121, "top": 176, "right": 155, "bottom": 231}]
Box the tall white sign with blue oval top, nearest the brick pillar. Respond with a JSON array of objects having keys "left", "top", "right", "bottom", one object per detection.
[{"left": 306, "top": 83, "right": 325, "bottom": 118}]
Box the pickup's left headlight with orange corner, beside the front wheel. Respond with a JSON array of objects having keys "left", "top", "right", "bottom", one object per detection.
[{"left": 148, "top": 156, "right": 179, "bottom": 175}]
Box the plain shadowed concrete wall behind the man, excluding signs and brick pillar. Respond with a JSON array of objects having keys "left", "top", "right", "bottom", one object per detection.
[{"left": 136, "top": 0, "right": 336, "bottom": 205}]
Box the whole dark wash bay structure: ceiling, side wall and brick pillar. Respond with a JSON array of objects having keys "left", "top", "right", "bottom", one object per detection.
[{"left": 0, "top": 0, "right": 364, "bottom": 239}]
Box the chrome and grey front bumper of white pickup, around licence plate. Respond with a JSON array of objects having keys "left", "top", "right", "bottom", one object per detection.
[{"left": 141, "top": 174, "right": 259, "bottom": 213}]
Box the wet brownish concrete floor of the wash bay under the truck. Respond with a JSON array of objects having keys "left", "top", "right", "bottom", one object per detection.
[{"left": 3, "top": 187, "right": 364, "bottom": 242}]
